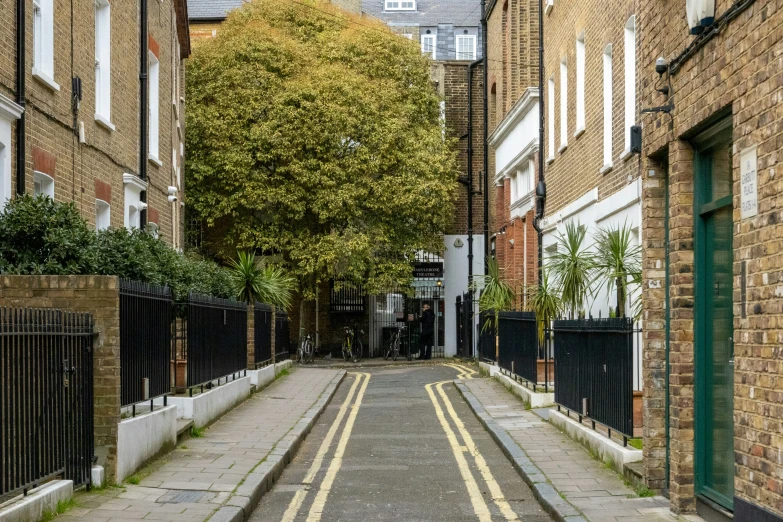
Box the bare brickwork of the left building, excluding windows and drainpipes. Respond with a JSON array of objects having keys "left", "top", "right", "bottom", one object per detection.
[{"left": 0, "top": 0, "right": 184, "bottom": 246}]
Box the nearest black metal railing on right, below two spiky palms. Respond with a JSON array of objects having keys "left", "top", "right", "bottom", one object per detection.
[{"left": 552, "top": 318, "right": 638, "bottom": 444}]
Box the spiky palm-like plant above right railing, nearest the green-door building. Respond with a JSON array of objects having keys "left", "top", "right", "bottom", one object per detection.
[{"left": 594, "top": 222, "right": 642, "bottom": 317}]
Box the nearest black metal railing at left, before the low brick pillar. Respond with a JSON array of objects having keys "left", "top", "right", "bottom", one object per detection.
[{"left": 0, "top": 308, "right": 94, "bottom": 502}]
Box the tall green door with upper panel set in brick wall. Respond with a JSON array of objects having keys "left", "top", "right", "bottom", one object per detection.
[{"left": 695, "top": 124, "right": 734, "bottom": 511}]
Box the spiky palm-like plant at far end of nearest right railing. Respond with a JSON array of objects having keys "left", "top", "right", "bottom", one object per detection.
[{"left": 547, "top": 221, "right": 595, "bottom": 317}]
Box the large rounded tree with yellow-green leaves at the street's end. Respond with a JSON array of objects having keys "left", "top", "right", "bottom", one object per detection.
[{"left": 186, "top": 0, "right": 456, "bottom": 298}]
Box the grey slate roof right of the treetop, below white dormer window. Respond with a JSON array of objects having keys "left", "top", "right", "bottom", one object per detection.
[{"left": 362, "top": 0, "right": 481, "bottom": 27}]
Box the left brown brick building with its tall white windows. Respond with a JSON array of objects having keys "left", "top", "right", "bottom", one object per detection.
[{"left": 0, "top": 0, "right": 190, "bottom": 248}]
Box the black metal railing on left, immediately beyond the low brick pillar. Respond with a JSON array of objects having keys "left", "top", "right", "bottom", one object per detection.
[{"left": 120, "top": 279, "right": 173, "bottom": 408}]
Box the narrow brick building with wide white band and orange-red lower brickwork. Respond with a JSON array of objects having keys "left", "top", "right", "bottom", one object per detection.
[{"left": 487, "top": 0, "right": 539, "bottom": 300}]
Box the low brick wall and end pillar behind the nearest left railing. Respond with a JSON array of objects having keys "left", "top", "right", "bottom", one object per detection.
[{"left": 0, "top": 276, "right": 120, "bottom": 482}]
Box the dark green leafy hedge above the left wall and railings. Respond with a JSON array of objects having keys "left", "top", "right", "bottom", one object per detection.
[{"left": 0, "top": 195, "right": 235, "bottom": 300}]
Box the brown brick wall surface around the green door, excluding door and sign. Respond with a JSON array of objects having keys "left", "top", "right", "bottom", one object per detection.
[{"left": 638, "top": 0, "right": 783, "bottom": 517}]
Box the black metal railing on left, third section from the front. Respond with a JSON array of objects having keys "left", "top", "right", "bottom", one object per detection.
[{"left": 178, "top": 293, "right": 247, "bottom": 393}]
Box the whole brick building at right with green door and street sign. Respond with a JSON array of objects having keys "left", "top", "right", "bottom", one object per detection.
[{"left": 640, "top": 0, "right": 783, "bottom": 522}]
